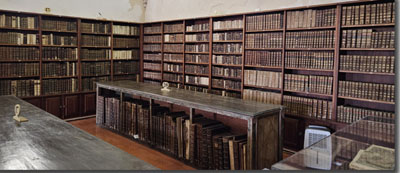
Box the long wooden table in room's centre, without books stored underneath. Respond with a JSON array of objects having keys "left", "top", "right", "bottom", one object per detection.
[{"left": 97, "top": 81, "right": 284, "bottom": 169}]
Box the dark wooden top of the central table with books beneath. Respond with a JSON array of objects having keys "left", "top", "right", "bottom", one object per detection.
[{"left": 97, "top": 80, "right": 283, "bottom": 119}]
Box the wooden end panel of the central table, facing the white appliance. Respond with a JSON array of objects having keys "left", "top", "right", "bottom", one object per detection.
[{"left": 253, "top": 113, "right": 279, "bottom": 169}]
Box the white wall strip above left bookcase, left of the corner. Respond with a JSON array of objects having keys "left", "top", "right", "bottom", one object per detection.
[{"left": 0, "top": 0, "right": 144, "bottom": 22}]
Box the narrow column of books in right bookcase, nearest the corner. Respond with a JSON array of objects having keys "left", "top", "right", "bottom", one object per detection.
[{"left": 143, "top": 23, "right": 163, "bottom": 84}]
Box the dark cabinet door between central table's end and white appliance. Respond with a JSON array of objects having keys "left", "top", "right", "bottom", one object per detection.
[{"left": 283, "top": 117, "right": 304, "bottom": 150}]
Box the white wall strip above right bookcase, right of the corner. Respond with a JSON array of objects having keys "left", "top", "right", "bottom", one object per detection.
[{"left": 144, "top": 0, "right": 351, "bottom": 22}]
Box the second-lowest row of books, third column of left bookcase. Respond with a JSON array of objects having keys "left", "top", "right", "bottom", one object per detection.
[{"left": 81, "top": 62, "right": 111, "bottom": 76}]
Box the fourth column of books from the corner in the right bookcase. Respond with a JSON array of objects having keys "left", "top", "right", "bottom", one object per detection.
[{"left": 211, "top": 15, "right": 245, "bottom": 98}]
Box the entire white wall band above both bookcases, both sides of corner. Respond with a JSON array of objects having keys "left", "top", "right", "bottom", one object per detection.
[{"left": 0, "top": 0, "right": 351, "bottom": 22}]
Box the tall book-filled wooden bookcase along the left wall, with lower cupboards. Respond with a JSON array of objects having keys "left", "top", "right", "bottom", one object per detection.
[{"left": 0, "top": 10, "right": 141, "bottom": 119}]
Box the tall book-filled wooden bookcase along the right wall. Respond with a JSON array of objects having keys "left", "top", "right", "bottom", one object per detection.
[{"left": 141, "top": 1, "right": 395, "bottom": 150}]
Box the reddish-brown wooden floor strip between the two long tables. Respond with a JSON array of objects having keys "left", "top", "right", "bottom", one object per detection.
[{"left": 69, "top": 118, "right": 289, "bottom": 170}]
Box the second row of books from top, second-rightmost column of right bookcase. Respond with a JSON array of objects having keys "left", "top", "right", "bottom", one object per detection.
[{"left": 286, "top": 30, "right": 335, "bottom": 48}]
